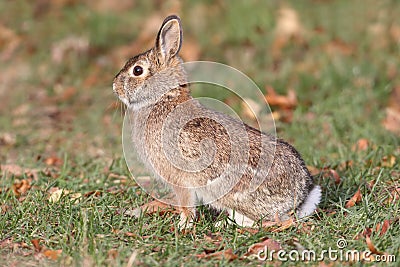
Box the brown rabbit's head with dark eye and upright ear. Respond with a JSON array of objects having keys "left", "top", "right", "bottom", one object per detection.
[{"left": 113, "top": 15, "right": 186, "bottom": 110}]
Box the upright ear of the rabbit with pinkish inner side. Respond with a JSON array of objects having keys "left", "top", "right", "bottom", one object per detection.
[{"left": 156, "top": 15, "right": 182, "bottom": 61}]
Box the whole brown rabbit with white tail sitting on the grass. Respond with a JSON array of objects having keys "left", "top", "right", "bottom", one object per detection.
[{"left": 113, "top": 15, "right": 321, "bottom": 228}]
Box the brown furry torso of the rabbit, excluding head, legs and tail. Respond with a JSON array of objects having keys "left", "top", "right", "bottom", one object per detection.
[{"left": 133, "top": 87, "right": 312, "bottom": 220}]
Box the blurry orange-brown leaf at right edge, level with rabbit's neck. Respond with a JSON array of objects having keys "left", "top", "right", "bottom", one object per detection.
[{"left": 382, "top": 86, "right": 400, "bottom": 135}]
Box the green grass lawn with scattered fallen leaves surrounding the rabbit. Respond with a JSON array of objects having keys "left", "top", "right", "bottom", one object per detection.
[{"left": 0, "top": 0, "right": 400, "bottom": 266}]
